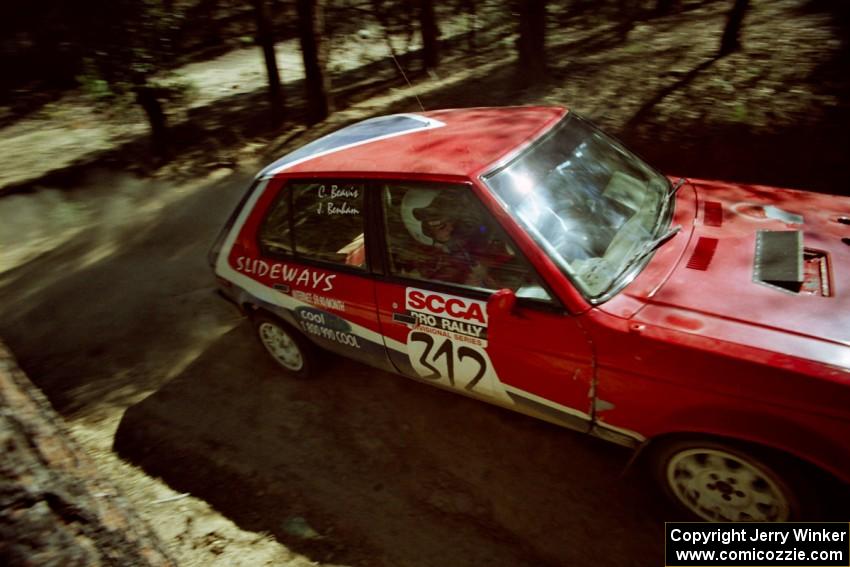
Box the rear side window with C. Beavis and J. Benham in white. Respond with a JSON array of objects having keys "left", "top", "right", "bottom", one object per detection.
[{"left": 260, "top": 182, "right": 366, "bottom": 269}]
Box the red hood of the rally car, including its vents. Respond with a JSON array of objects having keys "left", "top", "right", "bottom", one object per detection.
[{"left": 626, "top": 180, "right": 850, "bottom": 369}]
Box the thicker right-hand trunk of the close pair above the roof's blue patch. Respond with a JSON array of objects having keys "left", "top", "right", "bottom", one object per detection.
[{"left": 296, "top": 0, "right": 331, "bottom": 124}]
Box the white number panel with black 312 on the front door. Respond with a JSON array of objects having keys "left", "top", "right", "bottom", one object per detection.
[{"left": 408, "top": 331, "right": 491, "bottom": 392}]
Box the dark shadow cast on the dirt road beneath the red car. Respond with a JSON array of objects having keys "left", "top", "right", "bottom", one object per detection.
[{"left": 114, "top": 324, "right": 664, "bottom": 567}]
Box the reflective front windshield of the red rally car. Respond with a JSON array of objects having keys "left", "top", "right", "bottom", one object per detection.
[{"left": 484, "top": 113, "right": 670, "bottom": 300}]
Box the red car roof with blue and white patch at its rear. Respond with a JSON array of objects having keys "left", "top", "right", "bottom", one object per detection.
[{"left": 260, "top": 106, "right": 567, "bottom": 177}]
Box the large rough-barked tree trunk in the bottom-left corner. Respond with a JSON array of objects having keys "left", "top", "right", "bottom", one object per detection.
[{"left": 0, "top": 343, "right": 176, "bottom": 567}]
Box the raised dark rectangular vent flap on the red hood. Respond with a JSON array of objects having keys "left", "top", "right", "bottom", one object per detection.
[{"left": 753, "top": 230, "right": 804, "bottom": 293}]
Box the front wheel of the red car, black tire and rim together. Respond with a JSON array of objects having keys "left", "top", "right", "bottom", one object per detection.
[{"left": 648, "top": 437, "right": 819, "bottom": 522}]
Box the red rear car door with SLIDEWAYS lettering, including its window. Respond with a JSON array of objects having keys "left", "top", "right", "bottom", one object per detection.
[{"left": 224, "top": 178, "right": 392, "bottom": 369}]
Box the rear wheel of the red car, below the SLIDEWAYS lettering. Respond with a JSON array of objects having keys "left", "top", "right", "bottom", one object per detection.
[{"left": 251, "top": 311, "right": 318, "bottom": 378}]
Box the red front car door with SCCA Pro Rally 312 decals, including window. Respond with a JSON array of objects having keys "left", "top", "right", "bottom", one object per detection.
[{"left": 376, "top": 182, "right": 593, "bottom": 430}]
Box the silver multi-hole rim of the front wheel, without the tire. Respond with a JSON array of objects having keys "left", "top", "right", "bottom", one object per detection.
[{"left": 667, "top": 449, "right": 791, "bottom": 522}]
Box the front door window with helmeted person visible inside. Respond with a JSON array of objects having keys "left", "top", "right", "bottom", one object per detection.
[{"left": 382, "top": 184, "right": 551, "bottom": 300}]
